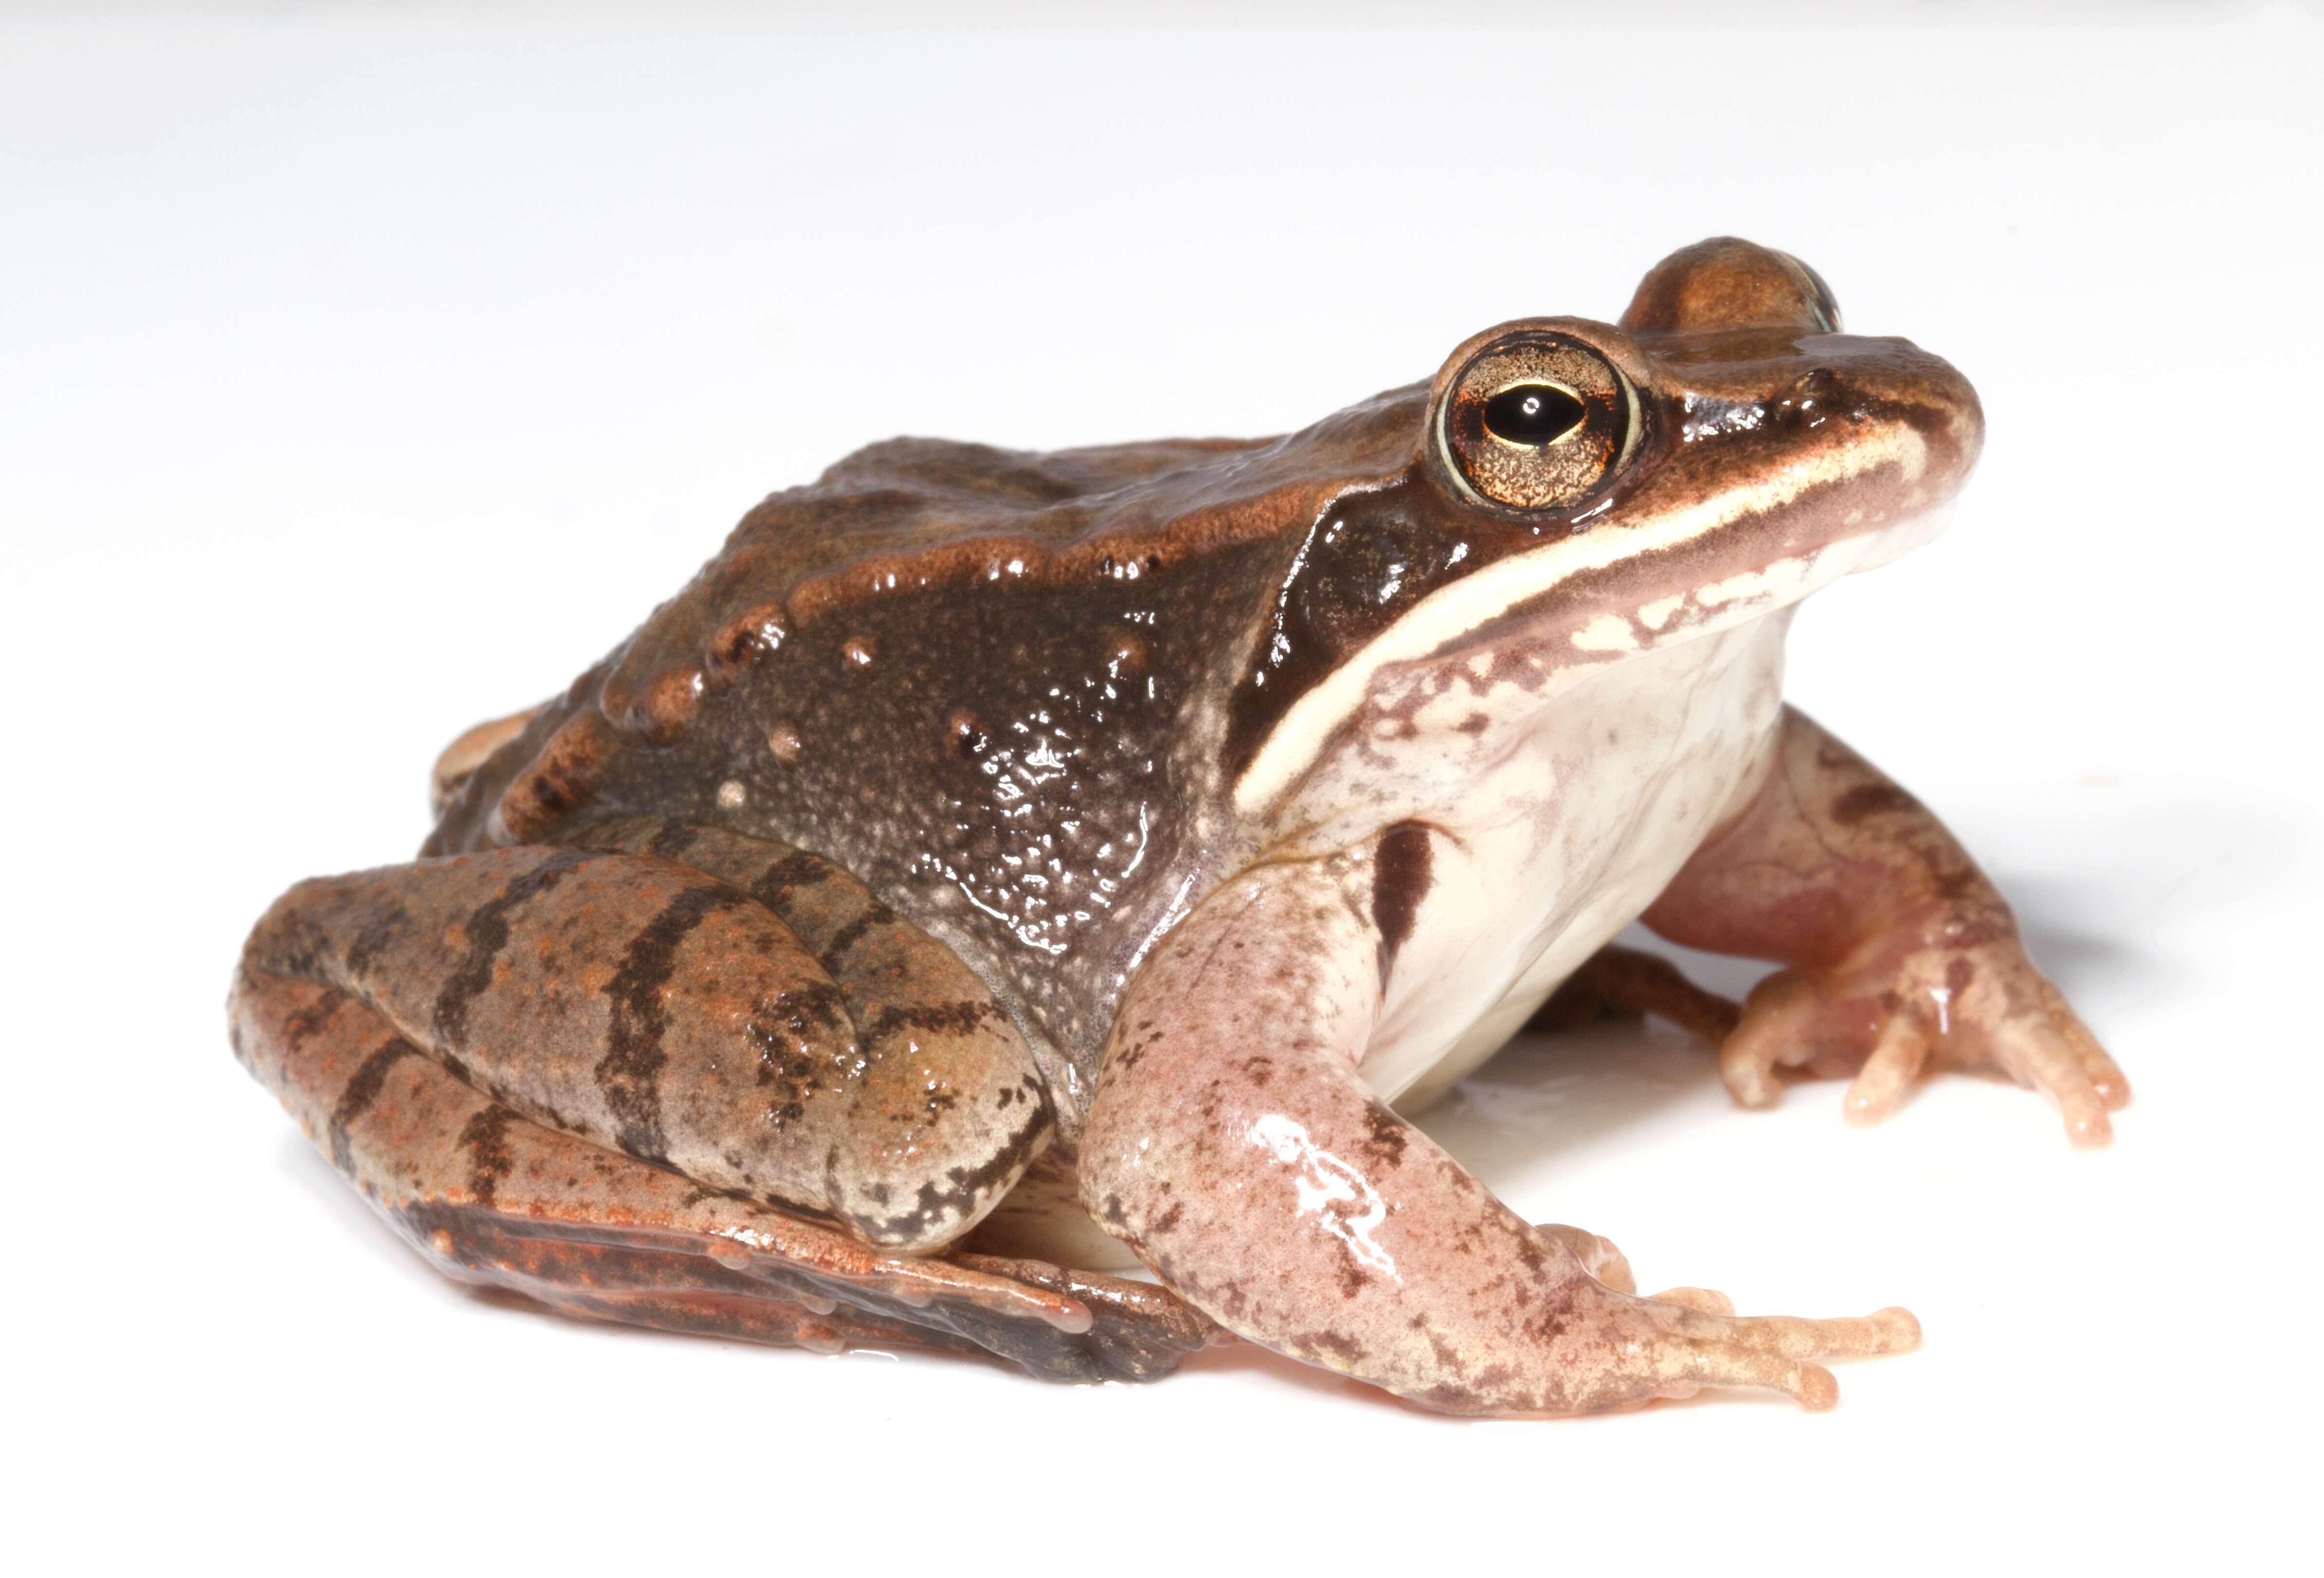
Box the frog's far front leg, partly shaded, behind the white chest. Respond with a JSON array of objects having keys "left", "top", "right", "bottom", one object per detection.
[{"left": 1645, "top": 707, "right": 2131, "bottom": 1146}]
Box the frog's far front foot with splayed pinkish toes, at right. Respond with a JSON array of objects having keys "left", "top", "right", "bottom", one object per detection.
[{"left": 1720, "top": 934, "right": 2131, "bottom": 1146}]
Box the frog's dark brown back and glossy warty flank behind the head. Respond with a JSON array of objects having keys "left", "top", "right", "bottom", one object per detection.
[{"left": 425, "top": 407, "right": 1418, "bottom": 1062}]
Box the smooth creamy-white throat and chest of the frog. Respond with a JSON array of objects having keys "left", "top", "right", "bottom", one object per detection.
[{"left": 1364, "top": 609, "right": 1792, "bottom": 1108}]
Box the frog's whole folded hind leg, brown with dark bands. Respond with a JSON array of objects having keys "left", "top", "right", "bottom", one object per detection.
[{"left": 232, "top": 823, "right": 1211, "bottom": 1378}]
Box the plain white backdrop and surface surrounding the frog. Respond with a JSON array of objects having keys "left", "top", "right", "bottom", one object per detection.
[{"left": 0, "top": 5, "right": 2324, "bottom": 1571}]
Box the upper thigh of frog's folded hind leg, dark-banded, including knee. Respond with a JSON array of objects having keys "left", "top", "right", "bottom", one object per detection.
[{"left": 244, "top": 848, "right": 1053, "bottom": 1253}]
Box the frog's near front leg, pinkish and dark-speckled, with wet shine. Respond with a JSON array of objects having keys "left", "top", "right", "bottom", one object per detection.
[{"left": 1080, "top": 858, "right": 1917, "bottom": 1415}]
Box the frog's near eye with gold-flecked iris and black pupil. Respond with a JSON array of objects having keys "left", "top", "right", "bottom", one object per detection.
[{"left": 1436, "top": 330, "right": 1638, "bottom": 516}]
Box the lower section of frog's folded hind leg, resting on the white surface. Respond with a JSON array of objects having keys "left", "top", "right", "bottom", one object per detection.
[{"left": 232, "top": 972, "right": 1213, "bottom": 1380}]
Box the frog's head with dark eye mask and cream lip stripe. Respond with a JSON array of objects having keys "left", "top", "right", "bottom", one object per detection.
[{"left": 1229, "top": 237, "right": 1985, "bottom": 809}]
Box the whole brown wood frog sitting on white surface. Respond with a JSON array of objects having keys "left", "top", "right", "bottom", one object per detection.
[{"left": 230, "top": 239, "right": 2129, "bottom": 1415}]
